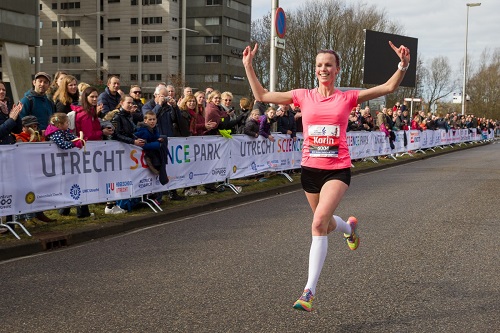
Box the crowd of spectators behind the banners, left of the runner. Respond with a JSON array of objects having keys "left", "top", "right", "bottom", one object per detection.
[{"left": 0, "top": 71, "right": 302, "bottom": 228}]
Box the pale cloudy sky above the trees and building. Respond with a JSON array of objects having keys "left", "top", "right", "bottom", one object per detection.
[{"left": 252, "top": 0, "right": 500, "bottom": 72}]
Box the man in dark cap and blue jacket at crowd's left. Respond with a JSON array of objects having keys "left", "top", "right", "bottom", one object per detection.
[{"left": 20, "top": 72, "right": 55, "bottom": 131}]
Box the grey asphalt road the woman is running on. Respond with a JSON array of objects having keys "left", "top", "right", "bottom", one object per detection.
[{"left": 0, "top": 144, "right": 500, "bottom": 333}]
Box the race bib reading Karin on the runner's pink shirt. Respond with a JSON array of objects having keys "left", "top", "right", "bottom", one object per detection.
[{"left": 308, "top": 125, "right": 340, "bottom": 157}]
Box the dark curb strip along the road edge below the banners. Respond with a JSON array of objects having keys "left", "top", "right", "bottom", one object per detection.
[{"left": 0, "top": 142, "right": 489, "bottom": 261}]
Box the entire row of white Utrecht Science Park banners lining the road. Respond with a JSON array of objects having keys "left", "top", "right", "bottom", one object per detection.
[{"left": 0, "top": 129, "right": 484, "bottom": 216}]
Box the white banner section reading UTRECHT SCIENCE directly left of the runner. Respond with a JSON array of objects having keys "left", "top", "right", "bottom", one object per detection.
[{"left": 230, "top": 133, "right": 303, "bottom": 179}]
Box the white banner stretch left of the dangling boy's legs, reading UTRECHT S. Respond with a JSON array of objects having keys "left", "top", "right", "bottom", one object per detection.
[{"left": 0, "top": 141, "right": 161, "bottom": 215}]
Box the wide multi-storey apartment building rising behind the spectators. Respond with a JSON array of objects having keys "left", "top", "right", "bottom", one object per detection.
[{"left": 36, "top": 0, "right": 251, "bottom": 95}]
